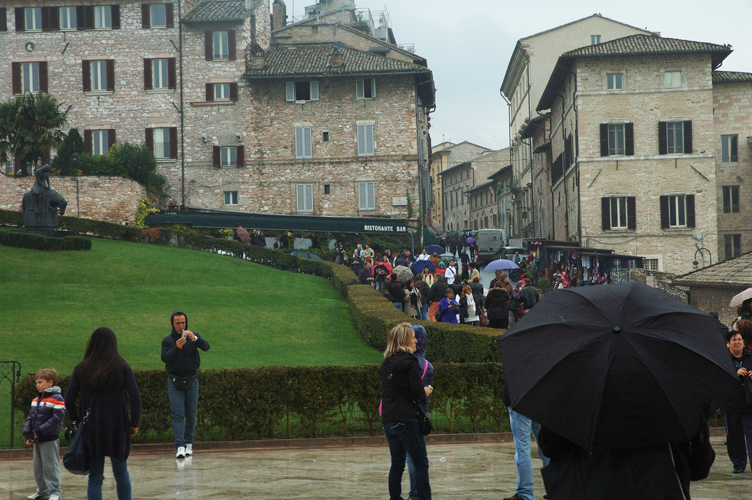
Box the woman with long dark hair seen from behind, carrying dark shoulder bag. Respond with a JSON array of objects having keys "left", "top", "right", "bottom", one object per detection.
[{"left": 65, "top": 327, "right": 141, "bottom": 500}]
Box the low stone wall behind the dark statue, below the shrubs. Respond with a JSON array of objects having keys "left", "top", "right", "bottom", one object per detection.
[{"left": 0, "top": 175, "right": 146, "bottom": 224}]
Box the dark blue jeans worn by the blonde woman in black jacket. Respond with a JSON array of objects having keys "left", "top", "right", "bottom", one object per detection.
[{"left": 381, "top": 420, "right": 431, "bottom": 500}]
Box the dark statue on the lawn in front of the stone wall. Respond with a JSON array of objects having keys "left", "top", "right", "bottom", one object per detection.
[{"left": 21, "top": 164, "right": 68, "bottom": 236}]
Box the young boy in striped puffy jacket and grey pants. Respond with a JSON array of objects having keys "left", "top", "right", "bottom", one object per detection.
[{"left": 23, "top": 368, "right": 65, "bottom": 500}]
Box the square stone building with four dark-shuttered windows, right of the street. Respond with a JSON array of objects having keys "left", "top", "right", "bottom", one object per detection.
[{"left": 537, "top": 35, "right": 731, "bottom": 273}]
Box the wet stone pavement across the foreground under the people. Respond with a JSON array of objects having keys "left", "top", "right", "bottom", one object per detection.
[{"left": 0, "top": 437, "right": 752, "bottom": 500}]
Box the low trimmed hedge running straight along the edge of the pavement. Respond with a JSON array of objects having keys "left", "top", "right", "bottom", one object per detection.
[{"left": 16, "top": 363, "right": 507, "bottom": 442}]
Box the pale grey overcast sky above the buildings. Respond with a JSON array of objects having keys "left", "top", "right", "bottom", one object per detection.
[{"left": 287, "top": 0, "right": 752, "bottom": 148}]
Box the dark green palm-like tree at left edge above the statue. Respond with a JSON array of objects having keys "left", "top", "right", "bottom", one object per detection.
[{"left": 0, "top": 94, "right": 68, "bottom": 172}]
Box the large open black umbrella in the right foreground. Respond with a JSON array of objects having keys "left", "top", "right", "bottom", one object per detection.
[{"left": 498, "top": 283, "right": 739, "bottom": 450}]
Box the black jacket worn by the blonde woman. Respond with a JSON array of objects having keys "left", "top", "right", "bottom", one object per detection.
[{"left": 381, "top": 352, "right": 426, "bottom": 422}]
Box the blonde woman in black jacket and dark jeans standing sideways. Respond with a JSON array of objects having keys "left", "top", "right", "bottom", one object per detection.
[{"left": 381, "top": 323, "right": 433, "bottom": 500}]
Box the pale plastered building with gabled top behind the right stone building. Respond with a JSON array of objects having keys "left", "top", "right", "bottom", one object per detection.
[{"left": 501, "top": 14, "right": 652, "bottom": 238}]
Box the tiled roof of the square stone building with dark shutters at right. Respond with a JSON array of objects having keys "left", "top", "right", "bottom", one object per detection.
[{"left": 536, "top": 35, "right": 731, "bottom": 111}]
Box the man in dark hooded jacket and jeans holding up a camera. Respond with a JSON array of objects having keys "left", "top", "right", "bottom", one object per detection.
[{"left": 162, "top": 311, "right": 209, "bottom": 458}]
